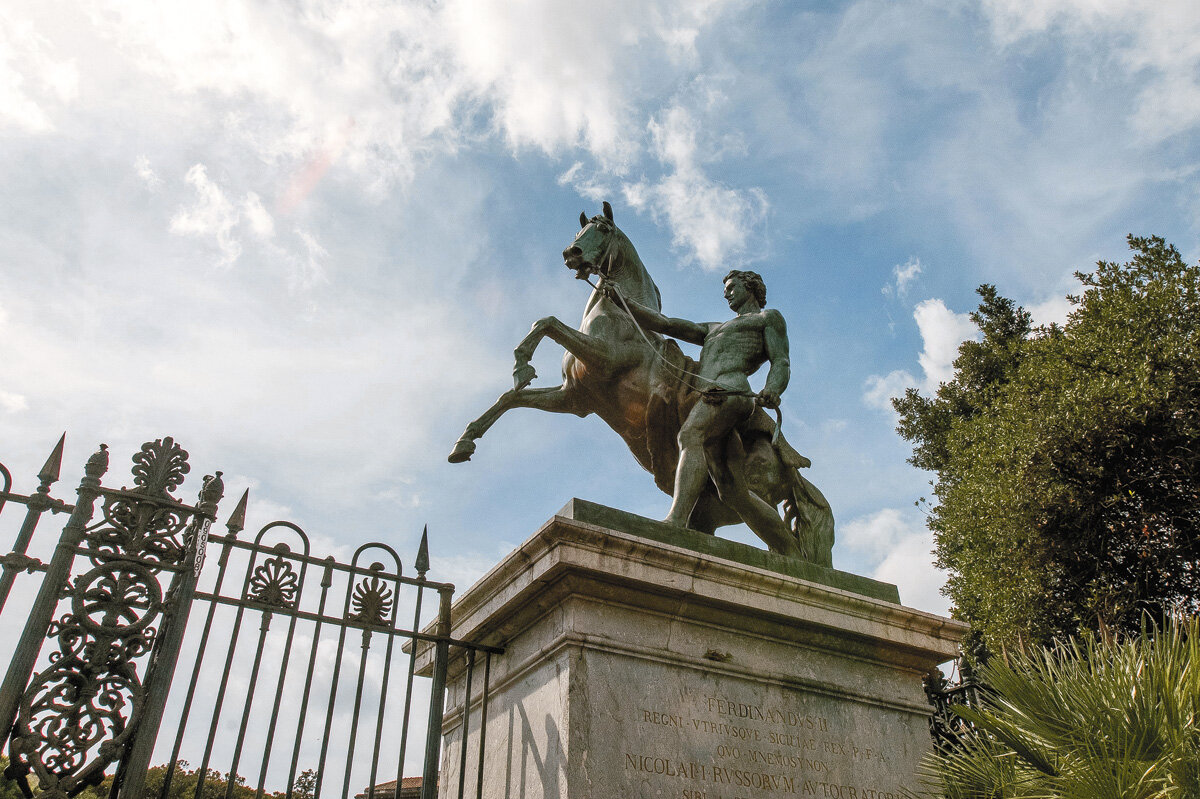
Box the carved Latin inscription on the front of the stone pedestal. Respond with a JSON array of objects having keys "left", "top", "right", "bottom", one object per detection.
[{"left": 624, "top": 692, "right": 902, "bottom": 799}]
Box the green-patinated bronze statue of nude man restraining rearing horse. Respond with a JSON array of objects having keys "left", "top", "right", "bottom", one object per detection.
[{"left": 450, "top": 203, "right": 833, "bottom": 566}]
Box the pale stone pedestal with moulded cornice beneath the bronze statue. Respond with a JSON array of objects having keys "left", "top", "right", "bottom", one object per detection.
[{"left": 422, "top": 499, "right": 965, "bottom": 799}]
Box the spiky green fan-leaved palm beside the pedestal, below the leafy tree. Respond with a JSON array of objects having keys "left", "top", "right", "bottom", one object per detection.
[{"left": 920, "top": 618, "right": 1200, "bottom": 799}]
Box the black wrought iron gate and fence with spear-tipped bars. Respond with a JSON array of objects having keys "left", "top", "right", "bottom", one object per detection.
[{"left": 0, "top": 438, "right": 500, "bottom": 799}]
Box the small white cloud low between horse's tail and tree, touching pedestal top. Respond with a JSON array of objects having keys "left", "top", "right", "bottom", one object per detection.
[{"left": 839, "top": 507, "right": 949, "bottom": 614}]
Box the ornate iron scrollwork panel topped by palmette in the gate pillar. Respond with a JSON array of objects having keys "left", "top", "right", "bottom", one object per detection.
[{"left": 8, "top": 438, "right": 223, "bottom": 797}]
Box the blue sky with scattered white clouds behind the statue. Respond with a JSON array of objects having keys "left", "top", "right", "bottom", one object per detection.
[{"left": 0, "top": 0, "right": 1200, "bottom": 613}]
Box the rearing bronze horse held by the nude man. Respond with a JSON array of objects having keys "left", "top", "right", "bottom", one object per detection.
[{"left": 450, "top": 203, "right": 833, "bottom": 566}]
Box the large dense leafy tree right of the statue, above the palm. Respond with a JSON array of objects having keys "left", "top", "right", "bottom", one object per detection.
[{"left": 895, "top": 236, "right": 1200, "bottom": 650}]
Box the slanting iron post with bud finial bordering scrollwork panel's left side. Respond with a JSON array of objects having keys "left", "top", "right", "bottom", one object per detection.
[{"left": 0, "top": 444, "right": 108, "bottom": 743}]
